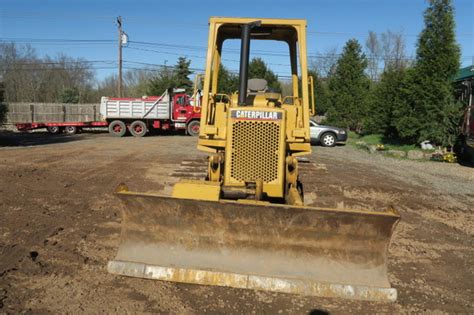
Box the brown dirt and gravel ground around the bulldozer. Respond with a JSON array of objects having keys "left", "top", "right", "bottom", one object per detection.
[{"left": 0, "top": 133, "right": 474, "bottom": 314}]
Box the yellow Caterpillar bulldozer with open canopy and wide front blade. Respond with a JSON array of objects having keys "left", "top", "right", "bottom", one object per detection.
[{"left": 108, "top": 17, "right": 400, "bottom": 301}]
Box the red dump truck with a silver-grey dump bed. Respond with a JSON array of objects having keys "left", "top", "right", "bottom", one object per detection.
[{"left": 100, "top": 89, "right": 201, "bottom": 137}]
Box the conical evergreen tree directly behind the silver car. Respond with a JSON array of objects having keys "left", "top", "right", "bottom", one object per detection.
[{"left": 327, "top": 39, "right": 369, "bottom": 132}]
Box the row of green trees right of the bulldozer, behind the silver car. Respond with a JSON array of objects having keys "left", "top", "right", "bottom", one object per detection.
[{"left": 315, "top": 0, "right": 463, "bottom": 146}]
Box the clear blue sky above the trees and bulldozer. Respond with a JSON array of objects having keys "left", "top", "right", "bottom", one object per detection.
[{"left": 0, "top": 0, "right": 474, "bottom": 80}]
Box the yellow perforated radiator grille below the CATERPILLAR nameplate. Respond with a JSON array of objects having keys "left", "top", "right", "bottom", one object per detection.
[{"left": 231, "top": 121, "right": 280, "bottom": 183}]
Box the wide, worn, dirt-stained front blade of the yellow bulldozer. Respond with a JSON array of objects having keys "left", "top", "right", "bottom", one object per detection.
[{"left": 108, "top": 190, "right": 400, "bottom": 301}]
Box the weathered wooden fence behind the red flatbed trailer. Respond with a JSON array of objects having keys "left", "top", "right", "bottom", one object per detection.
[{"left": 5, "top": 103, "right": 100, "bottom": 124}]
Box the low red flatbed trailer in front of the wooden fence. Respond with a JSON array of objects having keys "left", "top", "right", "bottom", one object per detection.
[{"left": 15, "top": 121, "right": 108, "bottom": 134}]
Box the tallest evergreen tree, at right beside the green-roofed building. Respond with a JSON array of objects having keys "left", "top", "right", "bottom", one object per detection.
[{"left": 395, "top": 0, "right": 461, "bottom": 146}]
